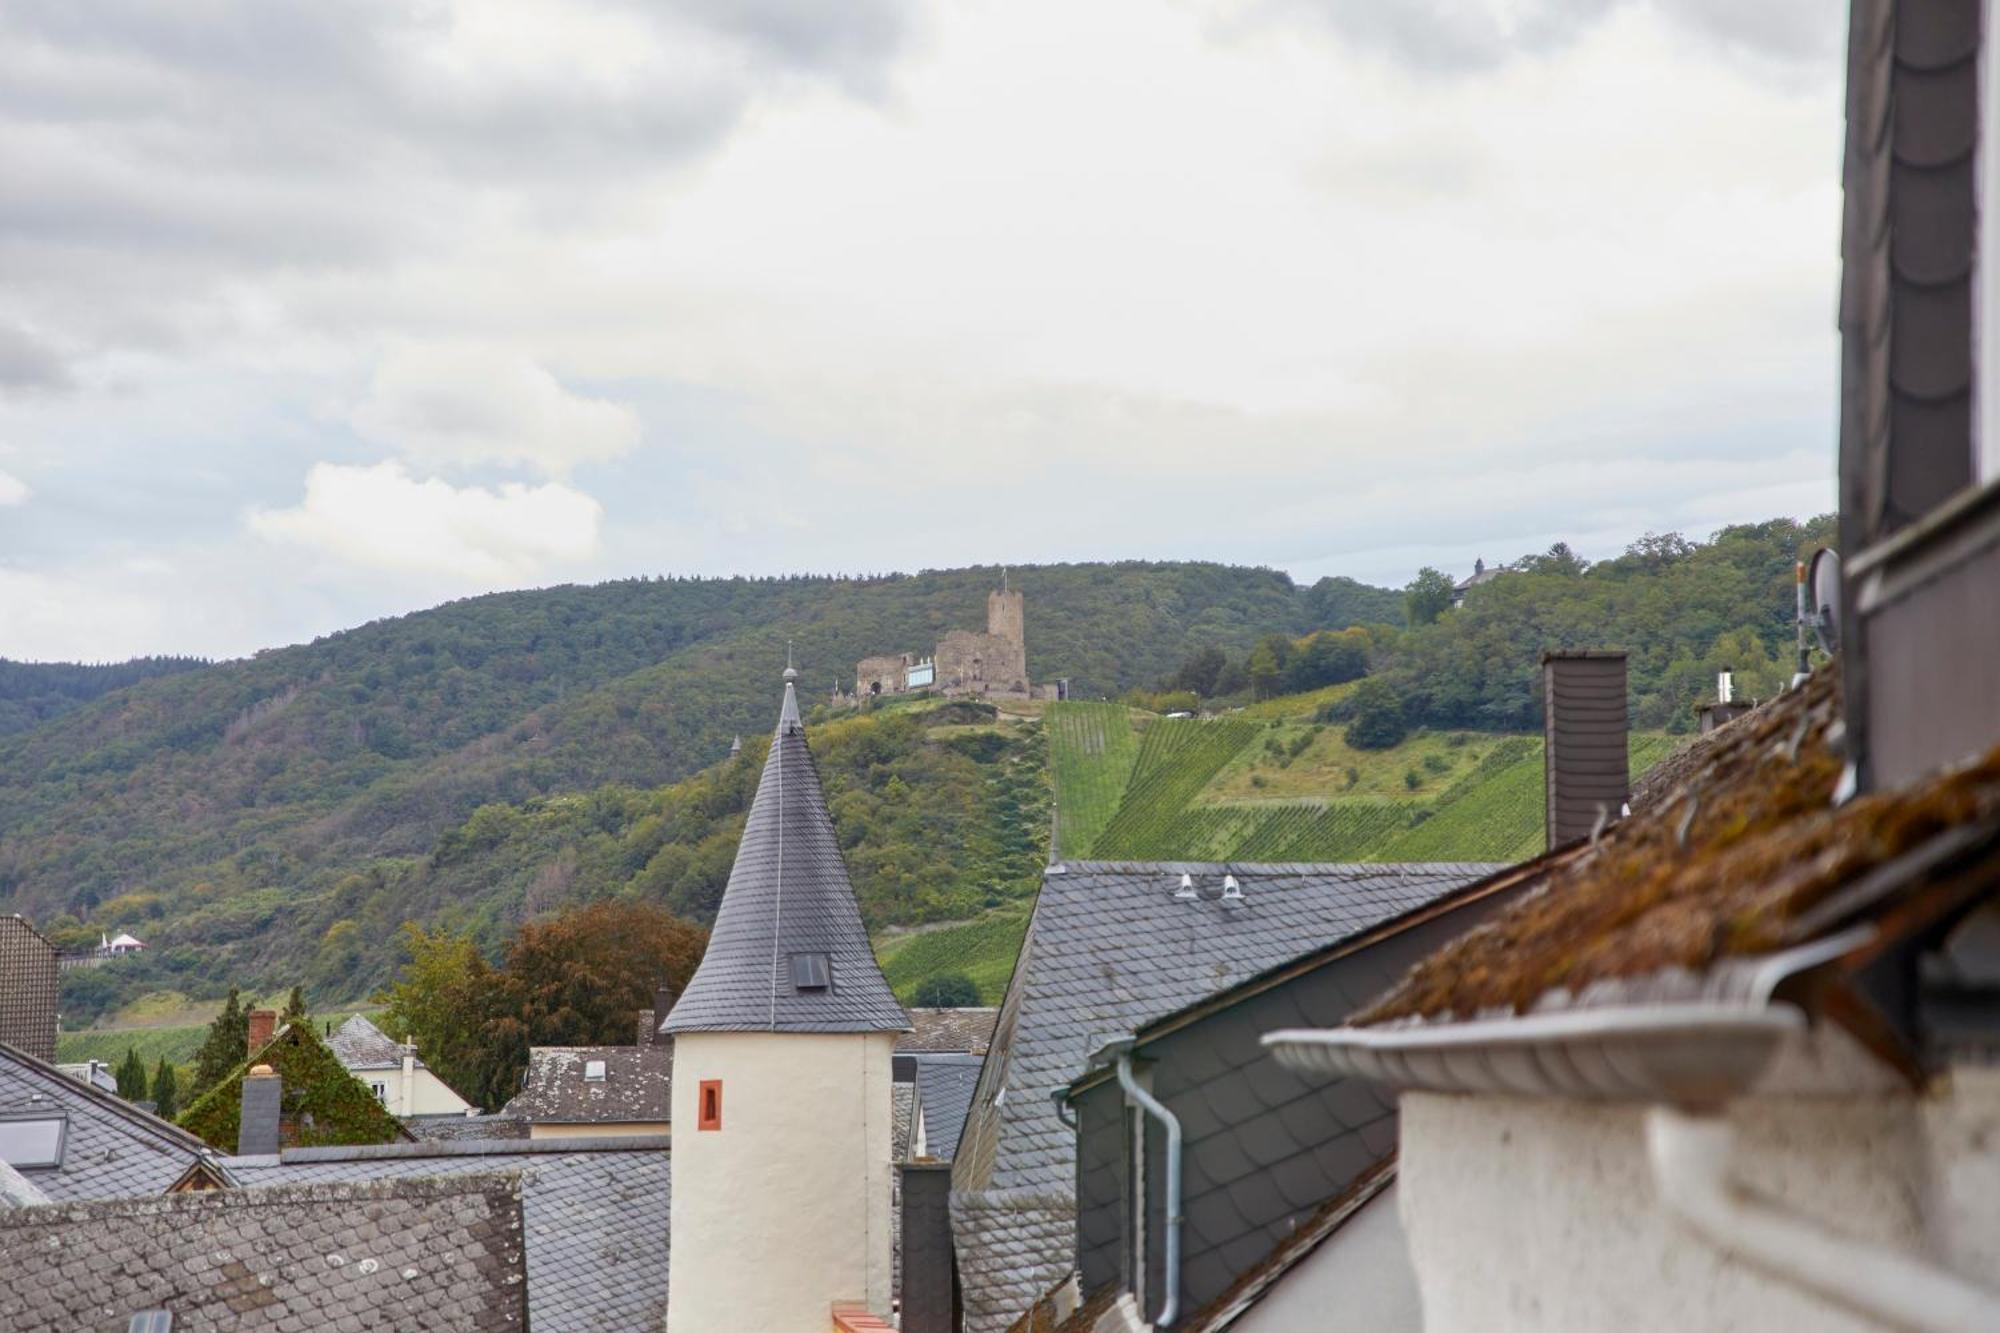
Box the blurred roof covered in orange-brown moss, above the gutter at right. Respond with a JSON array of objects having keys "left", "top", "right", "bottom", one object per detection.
[{"left": 1352, "top": 671, "right": 2000, "bottom": 1027}]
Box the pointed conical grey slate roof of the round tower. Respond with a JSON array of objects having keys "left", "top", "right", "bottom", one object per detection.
[{"left": 662, "top": 671, "right": 910, "bottom": 1033}]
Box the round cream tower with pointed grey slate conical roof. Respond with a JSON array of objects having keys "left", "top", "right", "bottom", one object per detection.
[{"left": 662, "top": 669, "right": 910, "bottom": 1333}]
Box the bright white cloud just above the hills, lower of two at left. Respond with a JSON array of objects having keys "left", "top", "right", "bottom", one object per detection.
[{"left": 250, "top": 462, "right": 602, "bottom": 582}]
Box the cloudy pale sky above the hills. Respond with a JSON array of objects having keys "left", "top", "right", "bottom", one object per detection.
[{"left": 0, "top": 0, "right": 1846, "bottom": 660}]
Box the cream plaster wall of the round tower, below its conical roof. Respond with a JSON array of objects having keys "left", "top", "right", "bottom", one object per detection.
[{"left": 666, "top": 1020, "right": 896, "bottom": 1333}]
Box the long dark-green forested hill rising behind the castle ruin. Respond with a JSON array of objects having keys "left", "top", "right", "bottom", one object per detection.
[{"left": 0, "top": 562, "right": 1360, "bottom": 932}]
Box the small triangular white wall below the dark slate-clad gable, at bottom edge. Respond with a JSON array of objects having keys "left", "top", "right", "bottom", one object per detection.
[{"left": 1230, "top": 1185, "right": 1424, "bottom": 1333}]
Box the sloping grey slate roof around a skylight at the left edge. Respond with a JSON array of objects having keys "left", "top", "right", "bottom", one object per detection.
[{"left": 0, "top": 1047, "right": 210, "bottom": 1203}]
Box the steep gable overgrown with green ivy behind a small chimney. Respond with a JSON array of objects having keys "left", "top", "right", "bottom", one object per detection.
[{"left": 176, "top": 1023, "right": 412, "bottom": 1153}]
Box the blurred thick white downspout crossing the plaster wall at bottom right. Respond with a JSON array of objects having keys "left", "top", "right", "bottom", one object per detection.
[{"left": 1646, "top": 1105, "right": 2000, "bottom": 1333}]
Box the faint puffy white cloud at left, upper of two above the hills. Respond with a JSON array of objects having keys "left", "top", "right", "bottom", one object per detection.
[{"left": 352, "top": 344, "right": 640, "bottom": 476}]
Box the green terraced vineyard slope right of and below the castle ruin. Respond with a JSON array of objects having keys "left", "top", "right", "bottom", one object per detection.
[{"left": 1050, "top": 700, "right": 1674, "bottom": 863}]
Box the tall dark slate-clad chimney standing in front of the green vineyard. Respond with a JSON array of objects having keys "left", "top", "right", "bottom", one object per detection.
[{"left": 1542, "top": 650, "right": 1630, "bottom": 849}]
